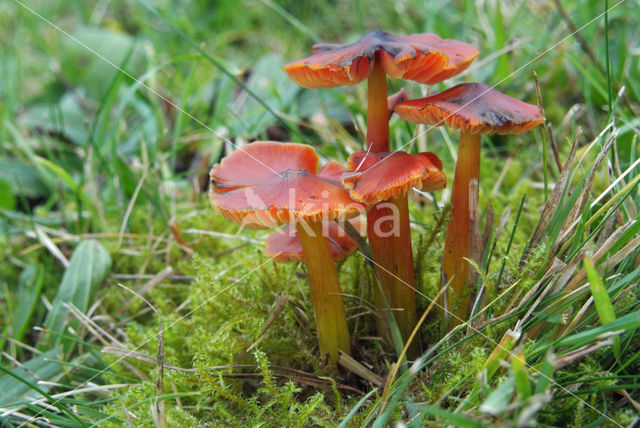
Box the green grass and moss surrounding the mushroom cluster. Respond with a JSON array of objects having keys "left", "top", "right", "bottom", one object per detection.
[{"left": 0, "top": 0, "right": 640, "bottom": 427}]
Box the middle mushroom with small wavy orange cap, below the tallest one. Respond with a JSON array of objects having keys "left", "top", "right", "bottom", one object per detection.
[{"left": 342, "top": 151, "right": 447, "bottom": 357}]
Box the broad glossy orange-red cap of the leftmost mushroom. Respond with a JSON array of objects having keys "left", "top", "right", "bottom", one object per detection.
[{"left": 209, "top": 141, "right": 364, "bottom": 229}]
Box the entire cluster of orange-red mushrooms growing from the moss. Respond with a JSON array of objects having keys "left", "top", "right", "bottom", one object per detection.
[{"left": 209, "top": 31, "right": 543, "bottom": 367}]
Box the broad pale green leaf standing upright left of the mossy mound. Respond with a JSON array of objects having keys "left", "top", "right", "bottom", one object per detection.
[{"left": 44, "top": 241, "right": 111, "bottom": 350}]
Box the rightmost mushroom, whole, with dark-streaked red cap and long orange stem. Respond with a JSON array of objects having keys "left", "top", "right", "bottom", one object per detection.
[{"left": 394, "top": 83, "right": 543, "bottom": 324}]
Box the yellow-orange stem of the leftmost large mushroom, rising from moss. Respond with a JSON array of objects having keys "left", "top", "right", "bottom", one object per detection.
[{"left": 296, "top": 221, "right": 351, "bottom": 367}]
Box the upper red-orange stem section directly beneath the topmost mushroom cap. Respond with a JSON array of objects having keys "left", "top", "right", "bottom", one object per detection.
[{"left": 367, "top": 58, "right": 389, "bottom": 152}]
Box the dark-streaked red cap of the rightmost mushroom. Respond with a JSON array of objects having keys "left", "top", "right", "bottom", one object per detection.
[{"left": 394, "top": 83, "right": 544, "bottom": 134}]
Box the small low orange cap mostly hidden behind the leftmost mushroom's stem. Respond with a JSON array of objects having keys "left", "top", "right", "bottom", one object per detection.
[{"left": 264, "top": 217, "right": 358, "bottom": 263}]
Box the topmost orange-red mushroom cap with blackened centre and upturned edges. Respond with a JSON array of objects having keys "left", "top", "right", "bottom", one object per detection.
[{"left": 284, "top": 30, "right": 479, "bottom": 89}]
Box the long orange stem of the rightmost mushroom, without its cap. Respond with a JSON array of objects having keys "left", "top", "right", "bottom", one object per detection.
[{"left": 442, "top": 131, "right": 481, "bottom": 325}]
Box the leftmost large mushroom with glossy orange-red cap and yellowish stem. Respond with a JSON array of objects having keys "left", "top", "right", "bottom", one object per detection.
[{"left": 209, "top": 141, "right": 364, "bottom": 367}]
